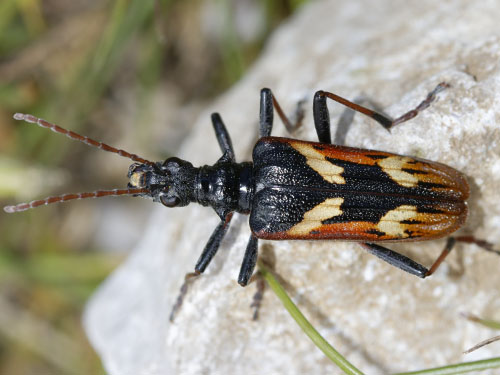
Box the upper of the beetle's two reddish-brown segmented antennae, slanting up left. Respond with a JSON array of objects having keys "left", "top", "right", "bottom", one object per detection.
[{"left": 14, "top": 113, "right": 155, "bottom": 166}]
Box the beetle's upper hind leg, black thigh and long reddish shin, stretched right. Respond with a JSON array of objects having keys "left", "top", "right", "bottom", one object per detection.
[{"left": 313, "top": 82, "right": 450, "bottom": 139}]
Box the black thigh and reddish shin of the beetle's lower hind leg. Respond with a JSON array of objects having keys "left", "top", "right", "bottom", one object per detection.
[{"left": 361, "top": 237, "right": 456, "bottom": 279}]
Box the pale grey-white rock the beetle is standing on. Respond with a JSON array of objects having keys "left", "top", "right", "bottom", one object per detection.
[{"left": 84, "top": 0, "right": 500, "bottom": 375}]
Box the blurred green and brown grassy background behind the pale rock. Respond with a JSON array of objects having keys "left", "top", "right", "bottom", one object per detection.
[{"left": 0, "top": 0, "right": 306, "bottom": 374}]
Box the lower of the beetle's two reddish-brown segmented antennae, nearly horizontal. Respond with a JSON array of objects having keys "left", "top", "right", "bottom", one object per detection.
[{"left": 3, "top": 189, "right": 151, "bottom": 214}]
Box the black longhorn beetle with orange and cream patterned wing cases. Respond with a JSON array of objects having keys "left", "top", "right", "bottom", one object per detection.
[{"left": 4, "top": 83, "right": 496, "bottom": 286}]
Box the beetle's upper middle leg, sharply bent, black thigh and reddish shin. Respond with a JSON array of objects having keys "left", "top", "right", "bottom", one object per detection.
[{"left": 259, "top": 89, "right": 304, "bottom": 137}]
